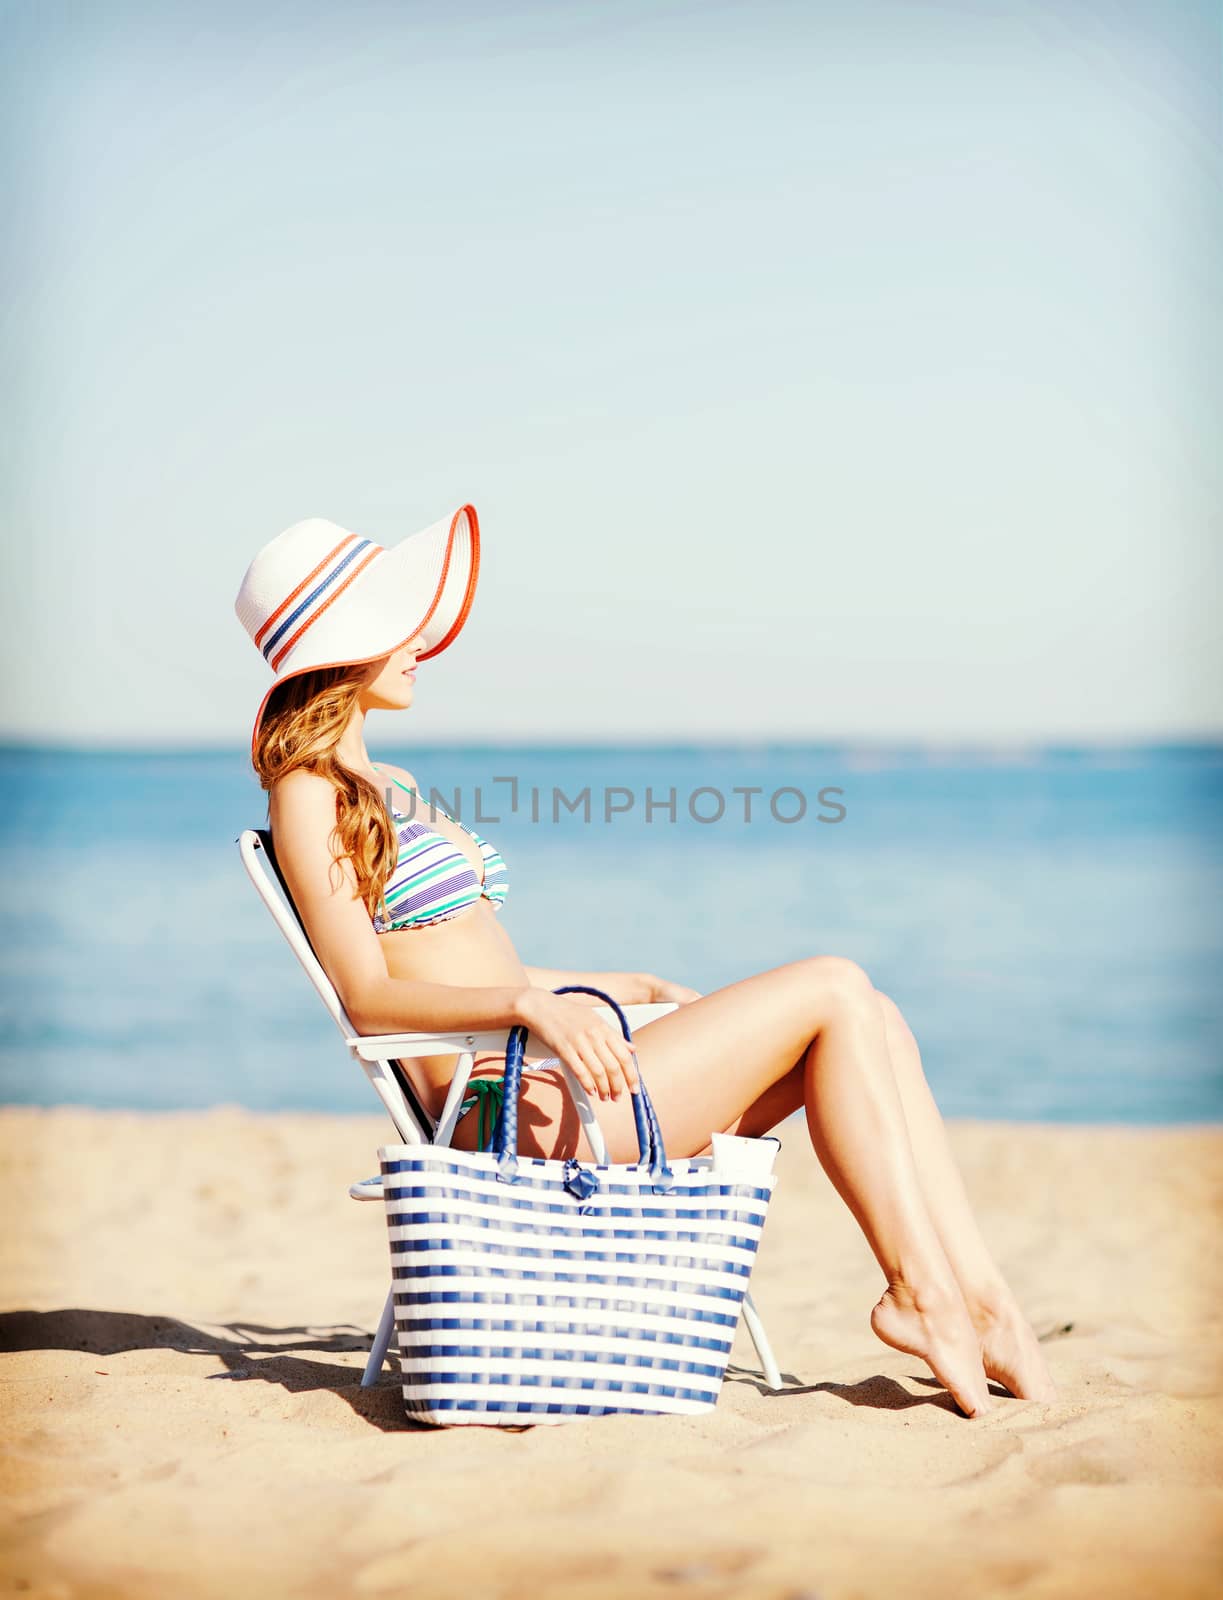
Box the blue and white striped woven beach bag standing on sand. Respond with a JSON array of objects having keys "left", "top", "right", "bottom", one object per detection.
[{"left": 379, "top": 984, "right": 780, "bottom": 1426}]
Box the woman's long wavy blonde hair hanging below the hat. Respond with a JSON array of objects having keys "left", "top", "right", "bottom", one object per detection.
[{"left": 253, "top": 662, "right": 399, "bottom": 918}]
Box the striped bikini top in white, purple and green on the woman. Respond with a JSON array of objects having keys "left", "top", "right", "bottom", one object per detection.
[{"left": 373, "top": 765, "right": 509, "bottom": 933}]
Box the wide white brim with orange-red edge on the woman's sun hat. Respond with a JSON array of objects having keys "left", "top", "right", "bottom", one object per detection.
[{"left": 239, "top": 506, "right": 480, "bottom": 754}]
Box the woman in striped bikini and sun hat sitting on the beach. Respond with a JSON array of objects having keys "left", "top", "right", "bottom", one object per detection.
[{"left": 237, "top": 506, "right": 1053, "bottom": 1416}]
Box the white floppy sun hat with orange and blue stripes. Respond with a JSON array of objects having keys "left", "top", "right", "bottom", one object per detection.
[{"left": 234, "top": 506, "right": 480, "bottom": 749}]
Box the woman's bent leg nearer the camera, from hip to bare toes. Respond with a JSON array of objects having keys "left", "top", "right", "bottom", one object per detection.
[{"left": 477, "top": 957, "right": 989, "bottom": 1416}]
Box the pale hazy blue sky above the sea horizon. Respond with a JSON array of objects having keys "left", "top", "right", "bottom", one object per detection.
[{"left": 0, "top": 0, "right": 1223, "bottom": 746}]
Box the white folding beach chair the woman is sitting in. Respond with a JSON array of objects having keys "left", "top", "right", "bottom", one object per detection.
[{"left": 237, "top": 829, "right": 781, "bottom": 1389}]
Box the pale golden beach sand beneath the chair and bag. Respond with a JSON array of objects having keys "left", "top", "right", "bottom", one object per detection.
[{"left": 0, "top": 1109, "right": 1223, "bottom": 1600}]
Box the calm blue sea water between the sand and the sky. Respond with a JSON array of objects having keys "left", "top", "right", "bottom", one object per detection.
[{"left": 0, "top": 746, "right": 1223, "bottom": 1123}]
